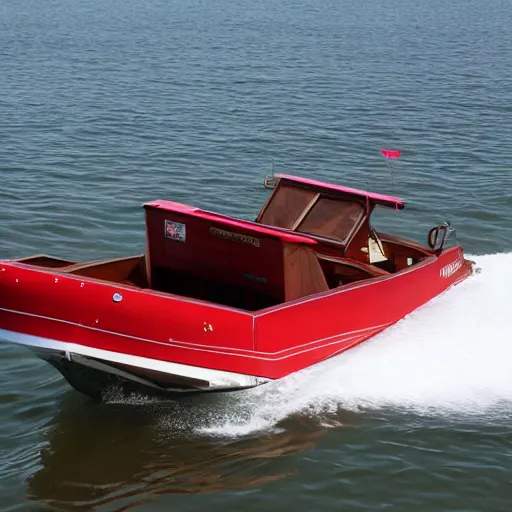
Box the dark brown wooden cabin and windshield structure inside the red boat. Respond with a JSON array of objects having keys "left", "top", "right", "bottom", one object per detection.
[{"left": 140, "top": 176, "right": 427, "bottom": 310}]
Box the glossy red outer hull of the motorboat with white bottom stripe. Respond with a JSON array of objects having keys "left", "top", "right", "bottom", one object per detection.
[{"left": 0, "top": 247, "right": 472, "bottom": 397}]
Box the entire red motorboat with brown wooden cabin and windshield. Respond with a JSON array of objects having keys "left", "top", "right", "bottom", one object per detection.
[{"left": 0, "top": 175, "right": 473, "bottom": 398}]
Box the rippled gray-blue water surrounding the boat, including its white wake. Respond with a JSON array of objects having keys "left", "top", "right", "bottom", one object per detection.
[{"left": 0, "top": 0, "right": 512, "bottom": 512}]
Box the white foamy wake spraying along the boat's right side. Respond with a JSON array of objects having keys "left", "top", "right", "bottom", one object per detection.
[{"left": 199, "top": 253, "right": 512, "bottom": 436}]
